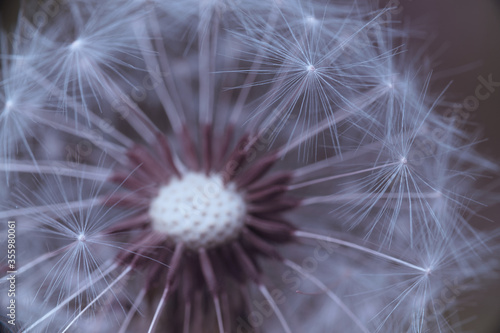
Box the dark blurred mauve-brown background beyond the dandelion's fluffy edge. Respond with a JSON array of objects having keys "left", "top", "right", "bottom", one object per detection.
[{"left": 0, "top": 0, "right": 500, "bottom": 333}]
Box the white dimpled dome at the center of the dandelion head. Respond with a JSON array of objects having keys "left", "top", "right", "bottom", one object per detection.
[{"left": 149, "top": 172, "right": 246, "bottom": 249}]
